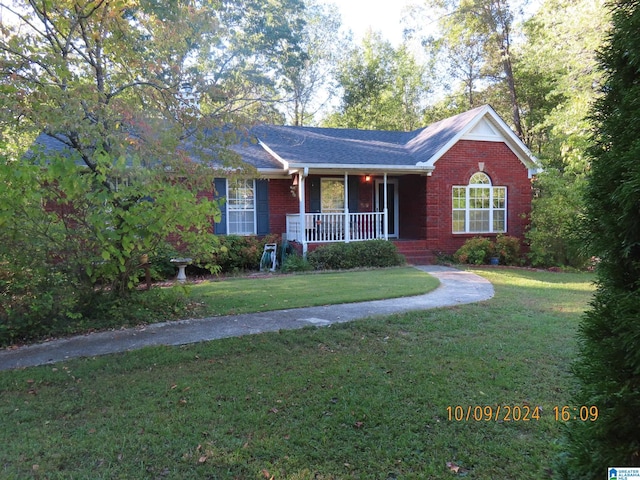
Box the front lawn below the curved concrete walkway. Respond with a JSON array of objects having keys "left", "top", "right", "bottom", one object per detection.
[{"left": 0, "top": 269, "right": 592, "bottom": 480}]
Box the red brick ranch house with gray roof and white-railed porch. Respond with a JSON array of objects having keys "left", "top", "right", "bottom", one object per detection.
[{"left": 214, "top": 105, "right": 539, "bottom": 261}]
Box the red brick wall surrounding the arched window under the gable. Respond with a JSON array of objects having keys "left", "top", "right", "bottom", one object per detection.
[{"left": 426, "top": 140, "right": 531, "bottom": 253}]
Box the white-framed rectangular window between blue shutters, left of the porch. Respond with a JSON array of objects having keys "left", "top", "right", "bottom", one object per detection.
[{"left": 227, "top": 179, "right": 256, "bottom": 235}]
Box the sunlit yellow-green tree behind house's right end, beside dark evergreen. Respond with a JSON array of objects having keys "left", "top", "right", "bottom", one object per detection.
[{"left": 515, "top": 0, "right": 609, "bottom": 174}]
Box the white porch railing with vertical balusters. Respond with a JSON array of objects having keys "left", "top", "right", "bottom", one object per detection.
[{"left": 287, "top": 212, "right": 384, "bottom": 243}]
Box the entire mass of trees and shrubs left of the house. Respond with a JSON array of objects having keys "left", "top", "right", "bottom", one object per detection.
[{"left": 0, "top": 0, "right": 304, "bottom": 339}]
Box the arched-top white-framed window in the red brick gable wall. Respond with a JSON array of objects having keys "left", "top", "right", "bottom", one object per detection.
[{"left": 452, "top": 172, "right": 507, "bottom": 233}]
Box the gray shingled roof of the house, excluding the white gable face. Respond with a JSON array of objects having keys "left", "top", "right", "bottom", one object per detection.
[{"left": 31, "top": 106, "right": 535, "bottom": 173}]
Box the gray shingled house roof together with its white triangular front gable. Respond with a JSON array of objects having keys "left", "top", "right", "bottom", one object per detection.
[{"left": 247, "top": 105, "right": 538, "bottom": 173}]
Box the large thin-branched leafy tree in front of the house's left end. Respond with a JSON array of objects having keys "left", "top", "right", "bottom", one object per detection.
[{"left": 0, "top": 0, "right": 301, "bottom": 294}]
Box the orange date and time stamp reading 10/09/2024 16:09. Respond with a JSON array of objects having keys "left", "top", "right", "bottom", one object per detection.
[{"left": 447, "top": 405, "right": 599, "bottom": 422}]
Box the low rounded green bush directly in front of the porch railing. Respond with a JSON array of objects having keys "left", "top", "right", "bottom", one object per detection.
[{"left": 307, "top": 240, "right": 405, "bottom": 270}]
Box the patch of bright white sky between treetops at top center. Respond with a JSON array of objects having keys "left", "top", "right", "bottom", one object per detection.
[{"left": 328, "top": 0, "right": 415, "bottom": 46}]
